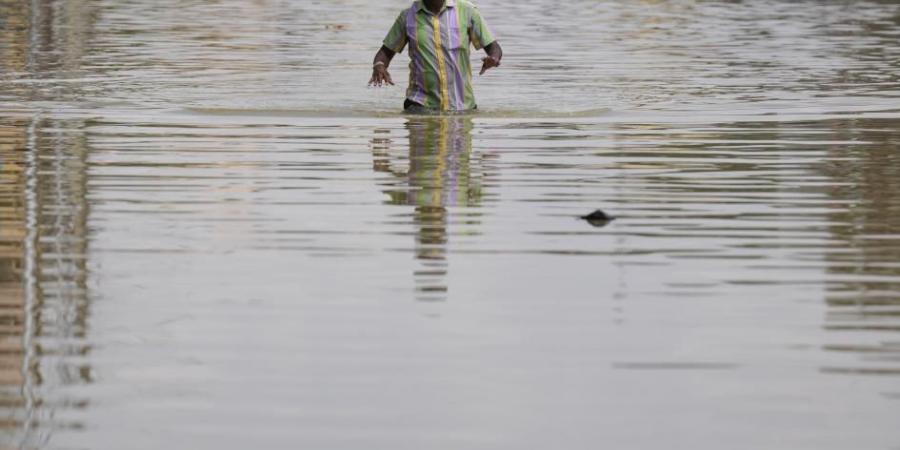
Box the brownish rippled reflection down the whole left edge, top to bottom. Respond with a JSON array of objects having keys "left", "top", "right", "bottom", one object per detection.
[{"left": 0, "top": 0, "right": 95, "bottom": 442}]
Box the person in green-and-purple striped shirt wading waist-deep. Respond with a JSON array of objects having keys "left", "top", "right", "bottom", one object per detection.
[{"left": 369, "top": 0, "right": 503, "bottom": 113}]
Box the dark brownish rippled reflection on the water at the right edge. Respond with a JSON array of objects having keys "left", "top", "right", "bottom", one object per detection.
[{"left": 823, "top": 119, "right": 900, "bottom": 373}]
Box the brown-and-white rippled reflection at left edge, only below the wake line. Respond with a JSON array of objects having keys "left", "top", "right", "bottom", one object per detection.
[{"left": 0, "top": 117, "right": 92, "bottom": 448}]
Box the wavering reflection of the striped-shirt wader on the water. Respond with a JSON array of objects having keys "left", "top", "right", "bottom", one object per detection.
[{"left": 373, "top": 117, "right": 481, "bottom": 299}]
